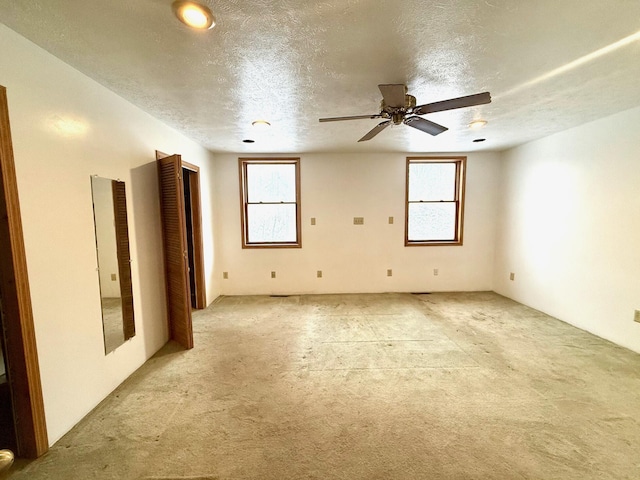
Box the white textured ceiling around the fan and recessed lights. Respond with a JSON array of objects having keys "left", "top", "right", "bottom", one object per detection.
[{"left": 0, "top": 0, "right": 640, "bottom": 153}]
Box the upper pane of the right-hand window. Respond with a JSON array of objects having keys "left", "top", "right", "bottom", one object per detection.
[{"left": 409, "top": 163, "right": 456, "bottom": 202}]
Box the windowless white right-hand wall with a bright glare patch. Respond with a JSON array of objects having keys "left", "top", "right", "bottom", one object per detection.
[{"left": 495, "top": 108, "right": 640, "bottom": 352}]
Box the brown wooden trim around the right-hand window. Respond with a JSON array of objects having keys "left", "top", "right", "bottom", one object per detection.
[{"left": 404, "top": 156, "right": 467, "bottom": 247}]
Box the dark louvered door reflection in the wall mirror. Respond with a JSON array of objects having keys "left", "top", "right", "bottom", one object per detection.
[{"left": 111, "top": 180, "right": 136, "bottom": 340}]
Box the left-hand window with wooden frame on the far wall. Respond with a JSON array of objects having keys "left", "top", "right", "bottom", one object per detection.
[{"left": 239, "top": 158, "right": 302, "bottom": 248}]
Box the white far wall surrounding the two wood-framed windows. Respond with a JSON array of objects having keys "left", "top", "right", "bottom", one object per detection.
[{"left": 214, "top": 153, "right": 500, "bottom": 295}]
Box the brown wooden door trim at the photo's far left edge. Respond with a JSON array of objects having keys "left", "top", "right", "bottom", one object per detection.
[{"left": 0, "top": 86, "right": 49, "bottom": 458}]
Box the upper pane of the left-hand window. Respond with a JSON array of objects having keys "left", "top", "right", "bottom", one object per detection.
[{"left": 247, "top": 163, "right": 296, "bottom": 203}]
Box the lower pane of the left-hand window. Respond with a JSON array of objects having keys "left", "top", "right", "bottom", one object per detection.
[{"left": 248, "top": 204, "right": 297, "bottom": 243}]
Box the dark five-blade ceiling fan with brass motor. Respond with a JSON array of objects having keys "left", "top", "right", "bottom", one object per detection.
[{"left": 320, "top": 83, "right": 491, "bottom": 142}]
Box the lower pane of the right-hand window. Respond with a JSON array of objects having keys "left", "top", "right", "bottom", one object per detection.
[{"left": 408, "top": 202, "right": 456, "bottom": 241}]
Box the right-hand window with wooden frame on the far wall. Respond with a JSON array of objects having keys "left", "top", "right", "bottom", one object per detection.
[{"left": 405, "top": 157, "right": 467, "bottom": 246}]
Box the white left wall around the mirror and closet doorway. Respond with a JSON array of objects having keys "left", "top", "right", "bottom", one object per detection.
[{"left": 0, "top": 25, "right": 218, "bottom": 443}]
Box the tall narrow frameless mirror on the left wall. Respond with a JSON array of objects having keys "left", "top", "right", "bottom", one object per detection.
[{"left": 91, "top": 175, "right": 135, "bottom": 354}]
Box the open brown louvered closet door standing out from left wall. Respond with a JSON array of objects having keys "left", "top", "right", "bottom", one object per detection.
[{"left": 158, "top": 155, "right": 193, "bottom": 348}]
